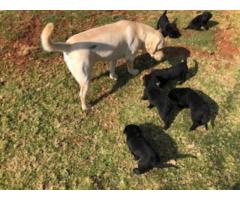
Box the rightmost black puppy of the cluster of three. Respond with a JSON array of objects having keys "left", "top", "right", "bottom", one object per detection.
[{"left": 168, "top": 88, "right": 211, "bottom": 131}]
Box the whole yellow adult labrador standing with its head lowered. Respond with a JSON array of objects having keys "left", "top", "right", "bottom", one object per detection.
[{"left": 41, "top": 20, "right": 164, "bottom": 110}]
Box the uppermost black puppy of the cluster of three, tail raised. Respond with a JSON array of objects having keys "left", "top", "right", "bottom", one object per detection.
[{"left": 151, "top": 60, "right": 188, "bottom": 87}]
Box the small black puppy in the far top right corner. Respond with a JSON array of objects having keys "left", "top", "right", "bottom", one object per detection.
[{"left": 185, "top": 11, "right": 212, "bottom": 30}]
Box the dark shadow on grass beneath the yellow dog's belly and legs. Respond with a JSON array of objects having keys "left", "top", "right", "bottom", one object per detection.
[{"left": 91, "top": 54, "right": 159, "bottom": 105}]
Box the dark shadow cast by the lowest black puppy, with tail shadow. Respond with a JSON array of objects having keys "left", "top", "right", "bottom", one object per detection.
[{"left": 139, "top": 123, "right": 197, "bottom": 162}]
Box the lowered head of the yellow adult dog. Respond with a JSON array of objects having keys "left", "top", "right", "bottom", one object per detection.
[{"left": 145, "top": 30, "right": 164, "bottom": 61}]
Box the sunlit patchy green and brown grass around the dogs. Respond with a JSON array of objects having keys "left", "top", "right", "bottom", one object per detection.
[{"left": 0, "top": 11, "right": 240, "bottom": 189}]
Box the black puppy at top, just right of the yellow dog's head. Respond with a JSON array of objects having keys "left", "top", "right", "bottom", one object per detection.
[{"left": 157, "top": 11, "right": 181, "bottom": 38}]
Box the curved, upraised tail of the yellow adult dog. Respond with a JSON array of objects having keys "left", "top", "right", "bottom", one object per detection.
[{"left": 41, "top": 23, "right": 71, "bottom": 52}]
